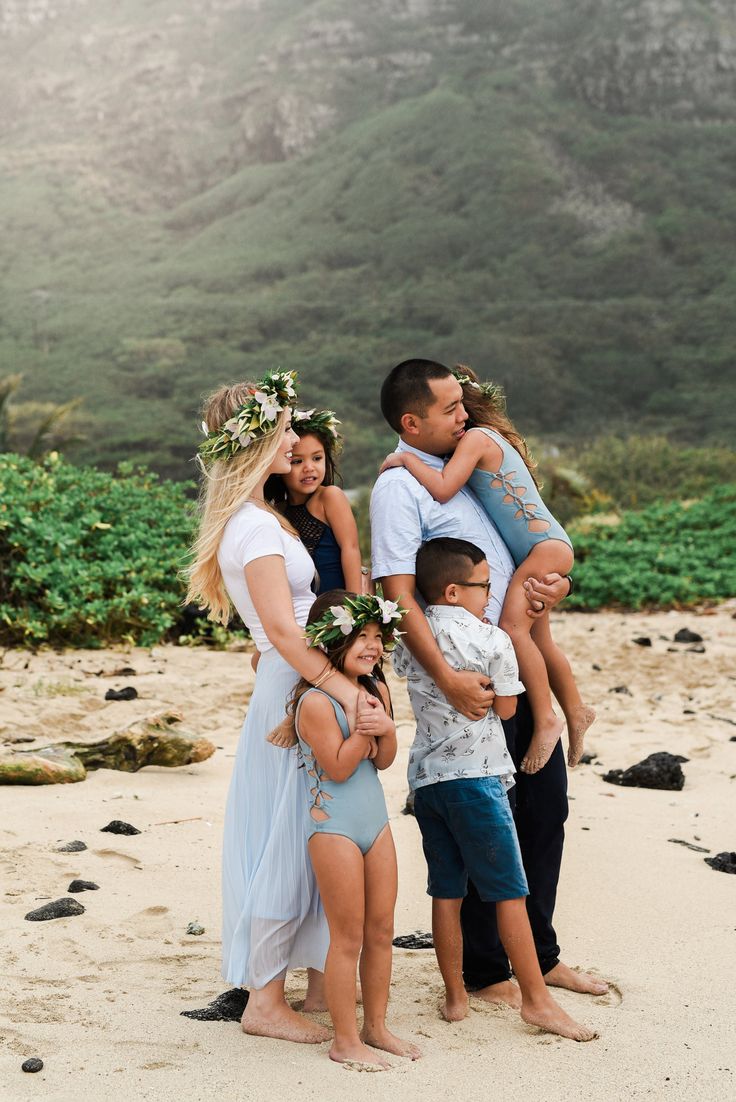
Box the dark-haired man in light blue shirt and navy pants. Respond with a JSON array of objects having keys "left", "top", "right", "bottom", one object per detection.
[{"left": 370, "top": 359, "right": 608, "bottom": 1007}]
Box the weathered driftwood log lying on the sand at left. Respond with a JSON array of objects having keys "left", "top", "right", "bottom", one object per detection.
[{"left": 0, "top": 712, "right": 215, "bottom": 785}]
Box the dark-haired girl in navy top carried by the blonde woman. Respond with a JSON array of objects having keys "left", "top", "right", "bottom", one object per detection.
[{"left": 266, "top": 410, "right": 364, "bottom": 594}]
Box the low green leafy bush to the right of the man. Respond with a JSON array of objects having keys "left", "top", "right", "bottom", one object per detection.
[{"left": 565, "top": 483, "right": 736, "bottom": 609}]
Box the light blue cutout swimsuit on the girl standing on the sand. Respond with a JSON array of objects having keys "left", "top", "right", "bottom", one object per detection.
[{"left": 296, "top": 689, "right": 389, "bottom": 856}]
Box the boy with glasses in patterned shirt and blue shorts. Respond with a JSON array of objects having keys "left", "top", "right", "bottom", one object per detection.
[{"left": 393, "top": 537, "right": 595, "bottom": 1040}]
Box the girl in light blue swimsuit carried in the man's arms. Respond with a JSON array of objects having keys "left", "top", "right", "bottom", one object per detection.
[{"left": 381, "top": 366, "right": 595, "bottom": 773}]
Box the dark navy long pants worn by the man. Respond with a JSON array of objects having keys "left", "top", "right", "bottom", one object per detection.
[{"left": 461, "top": 694, "right": 567, "bottom": 990}]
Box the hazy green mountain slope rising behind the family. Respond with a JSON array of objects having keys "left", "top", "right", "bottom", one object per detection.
[{"left": 0, "top": 0, "right": 736, "bottom": 483}]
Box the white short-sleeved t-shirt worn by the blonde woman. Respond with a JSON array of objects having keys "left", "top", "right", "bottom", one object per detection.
[{"left": 217, "top": 501, "right": 315, "bottom": 653}]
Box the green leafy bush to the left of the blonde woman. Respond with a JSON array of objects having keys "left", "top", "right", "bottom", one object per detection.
[{"left": 0, "top": 453, "right": 194, "bottom": 647}]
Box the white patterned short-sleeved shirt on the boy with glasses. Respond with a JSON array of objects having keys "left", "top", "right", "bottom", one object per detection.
[{"left": 392, "top": 605, "right": 524, "bottom": 791}]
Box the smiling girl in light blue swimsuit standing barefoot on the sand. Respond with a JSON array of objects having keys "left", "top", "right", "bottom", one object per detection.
[{"left": 290, "top": 590, "right": 420, "bottom": 1070}]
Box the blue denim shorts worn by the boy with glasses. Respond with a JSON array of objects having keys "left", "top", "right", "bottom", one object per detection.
[{"left": 414, "top": 777, "right": 529, "bottom": 903}]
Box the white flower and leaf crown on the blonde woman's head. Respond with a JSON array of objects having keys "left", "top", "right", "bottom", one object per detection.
[{"left": 198, "top": 371, "right": 296, "bottom": 460}]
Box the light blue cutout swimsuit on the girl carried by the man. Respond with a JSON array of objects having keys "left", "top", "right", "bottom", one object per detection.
[{"left": 467, "top": 425, "right": 573, "bottom": 566}]
